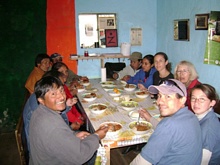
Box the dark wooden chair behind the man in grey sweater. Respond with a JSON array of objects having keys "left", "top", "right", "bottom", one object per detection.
[{"left": 15, "top": 114, "right": 29, "bottom": 165}]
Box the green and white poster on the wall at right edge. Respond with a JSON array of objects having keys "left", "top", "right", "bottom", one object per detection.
[{"left": 204, "top": 11, "right": 220, "bottom": 66}]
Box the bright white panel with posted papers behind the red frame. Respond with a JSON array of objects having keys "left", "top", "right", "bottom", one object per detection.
[{"left": 79, "top": 13, "right": 116, "bottom": 48}]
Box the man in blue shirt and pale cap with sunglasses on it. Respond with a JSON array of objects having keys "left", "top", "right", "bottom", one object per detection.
[{"left": 131, "top": 79, "right": 202, "bottom": 165}]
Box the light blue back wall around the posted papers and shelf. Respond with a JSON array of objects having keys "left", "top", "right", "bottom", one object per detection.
[{"left": 75, "top": 0, "right": 157, "bottom": 78}]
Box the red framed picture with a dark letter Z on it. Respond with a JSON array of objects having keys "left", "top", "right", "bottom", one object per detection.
[{"left": 105, "top": 29, "right": 118, "bottom": 47}]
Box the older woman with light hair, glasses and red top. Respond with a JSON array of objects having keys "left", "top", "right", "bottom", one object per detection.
[{"left": 174, "top": 61, "right": 201, "bottom": 110}]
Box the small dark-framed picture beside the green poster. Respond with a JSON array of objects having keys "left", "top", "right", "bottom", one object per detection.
[{"left": 195, "top": 13, "right": 209, "bottom": 30}]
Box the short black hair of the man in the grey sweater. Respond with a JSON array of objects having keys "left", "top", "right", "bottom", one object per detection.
[{"left": 34, "top": 76, "right": 63, "bottom": 99}]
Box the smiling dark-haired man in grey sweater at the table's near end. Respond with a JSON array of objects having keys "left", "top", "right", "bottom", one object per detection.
[{"left": 29, "top": 76, "right": 108, "bottom": 165}]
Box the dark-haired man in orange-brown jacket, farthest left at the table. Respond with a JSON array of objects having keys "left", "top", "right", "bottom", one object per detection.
[{"left": 25, "top": 53, "right": 50, "bottom": 94}]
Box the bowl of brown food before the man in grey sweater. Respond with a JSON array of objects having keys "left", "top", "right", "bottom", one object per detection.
[{"left": 100, "top": 121, "right": 122, "bottom": 136}]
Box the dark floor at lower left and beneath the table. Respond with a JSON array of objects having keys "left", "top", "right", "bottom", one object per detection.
[{"left": 0, "top": 132, "right": 139, "bottom": 165}]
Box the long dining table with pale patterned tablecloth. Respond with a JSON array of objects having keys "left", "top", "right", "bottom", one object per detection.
[{"left": 77, "top": 79, "right": 159, "bottom": 165}]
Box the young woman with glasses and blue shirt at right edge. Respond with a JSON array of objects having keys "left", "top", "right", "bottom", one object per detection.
[{"left": 191, "top": 84, "right": 220, "bottom": 165}]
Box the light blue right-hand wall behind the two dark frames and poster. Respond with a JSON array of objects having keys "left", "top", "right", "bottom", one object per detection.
[{"left": 157, "top": 0, "right": 220, "bottom": 94}]
